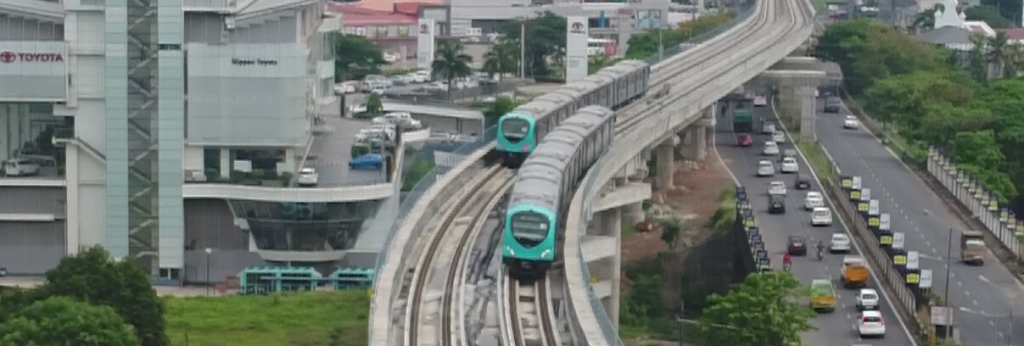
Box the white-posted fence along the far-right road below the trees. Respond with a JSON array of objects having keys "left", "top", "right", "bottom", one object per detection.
[{"left": 927, "top": 146, "right": 1024, "bottom": 262}]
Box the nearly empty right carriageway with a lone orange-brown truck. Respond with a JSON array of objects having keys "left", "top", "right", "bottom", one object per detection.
[{"left": 815, "top": 100, "right": 1024, "bottom": 346}]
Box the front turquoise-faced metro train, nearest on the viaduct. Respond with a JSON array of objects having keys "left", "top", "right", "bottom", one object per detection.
[{"left": 502, "top": 105, "right": 615, "bottom": 277}]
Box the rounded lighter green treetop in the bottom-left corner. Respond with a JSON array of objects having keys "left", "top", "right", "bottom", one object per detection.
[{"left": 0, "top": 297, "right": 139, "bottom": 346}]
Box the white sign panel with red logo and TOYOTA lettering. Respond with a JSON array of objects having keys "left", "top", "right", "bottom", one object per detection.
[{"left": 0, "top": 41, "right": 69, "bottom": 102}]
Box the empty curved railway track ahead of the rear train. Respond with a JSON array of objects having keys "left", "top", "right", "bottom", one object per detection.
[{"left": 404, "top": 165, "right": 515, "bottom": 346}]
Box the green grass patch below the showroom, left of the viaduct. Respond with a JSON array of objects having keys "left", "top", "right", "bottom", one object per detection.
[{"left": 164, "top": 291, "right": 370, "bottom": 346}]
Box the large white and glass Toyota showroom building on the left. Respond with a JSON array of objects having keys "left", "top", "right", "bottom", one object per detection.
[{"left": 0, "top": 0, "right": 393, "bottom": 280}]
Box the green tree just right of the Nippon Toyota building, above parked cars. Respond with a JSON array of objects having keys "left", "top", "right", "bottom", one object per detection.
[{"left": 328, "top": 34, "right": 387, "bottom": 81}]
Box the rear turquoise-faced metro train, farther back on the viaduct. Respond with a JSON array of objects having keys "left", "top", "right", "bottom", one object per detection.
[{"left": 496, "top": 60, "right": 650, "bottom": 168}]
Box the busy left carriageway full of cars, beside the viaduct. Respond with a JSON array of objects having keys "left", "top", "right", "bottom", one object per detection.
[{"left": 716, "top": 98, "right": 912, "bottom": 346}]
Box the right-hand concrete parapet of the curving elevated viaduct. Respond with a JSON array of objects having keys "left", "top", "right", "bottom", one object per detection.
[{"left": 565, "top": 0, "right": 813, "bottom": 346}]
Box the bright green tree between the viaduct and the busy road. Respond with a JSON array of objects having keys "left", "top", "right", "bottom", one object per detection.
[{"left": 697, "top": 272, "right": 815, "bottom": 346}]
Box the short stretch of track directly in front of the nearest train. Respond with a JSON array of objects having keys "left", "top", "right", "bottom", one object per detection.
[{"left": 502, "top": 271, "right": 560, "bottom": 346}]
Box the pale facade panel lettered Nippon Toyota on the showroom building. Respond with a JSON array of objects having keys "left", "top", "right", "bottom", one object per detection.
[{"left": 186, "top": 43, "right": 307, "bottom": 145}]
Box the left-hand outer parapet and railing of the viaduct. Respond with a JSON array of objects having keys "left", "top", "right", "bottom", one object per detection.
[{"left": 369, "top": 127, "right": 497, "bottom": 338}]
